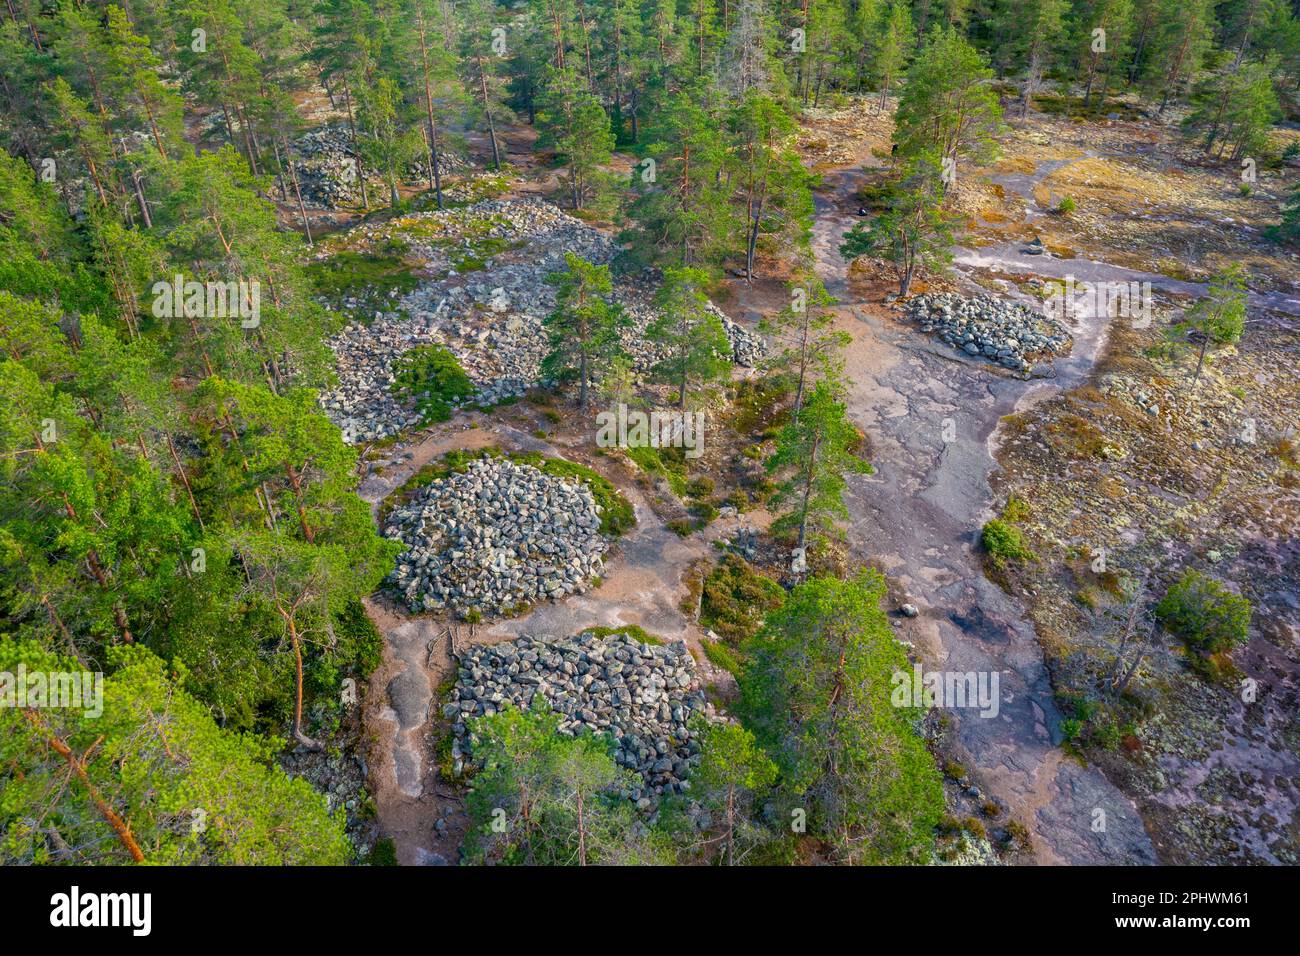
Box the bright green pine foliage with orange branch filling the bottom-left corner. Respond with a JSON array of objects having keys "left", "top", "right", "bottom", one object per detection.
[{"left": 0, "top": 640, "right": 351, "bottom": 866}]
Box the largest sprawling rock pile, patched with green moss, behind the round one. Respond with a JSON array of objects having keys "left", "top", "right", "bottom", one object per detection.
[{"left": 321, "top": 198, "right": 766, "bottom": 444}]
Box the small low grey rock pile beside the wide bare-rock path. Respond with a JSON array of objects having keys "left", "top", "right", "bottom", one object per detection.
[{"left": 907, "top": 293, "right": 1073, "bottom": 372}]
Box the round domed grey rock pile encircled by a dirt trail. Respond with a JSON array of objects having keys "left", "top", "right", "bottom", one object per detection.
[{"left": 384, "top": 458, "right": 607, "bottom": 617}]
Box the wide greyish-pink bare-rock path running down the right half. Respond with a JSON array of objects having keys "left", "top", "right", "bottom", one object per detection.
[{"left": 814, "top": 149, "right": 1156, "bottom": 864}]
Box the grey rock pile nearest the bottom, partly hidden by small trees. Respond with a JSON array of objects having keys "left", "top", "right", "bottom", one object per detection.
[{"left": 443, "top": 632, "right": 715, "bottom": 809}]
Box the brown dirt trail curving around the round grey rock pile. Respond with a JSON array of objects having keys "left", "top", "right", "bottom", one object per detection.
[{"left": 359, "top": 418, "right": 735, "bottom": 865}]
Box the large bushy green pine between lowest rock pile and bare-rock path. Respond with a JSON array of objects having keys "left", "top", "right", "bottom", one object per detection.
[{"left": 738, "top": 571, "right": 944, "bottom": 864}]
